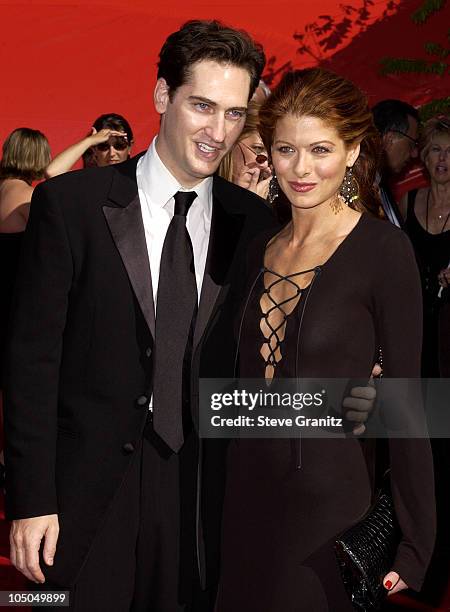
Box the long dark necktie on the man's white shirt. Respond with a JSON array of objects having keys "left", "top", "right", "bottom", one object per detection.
[{"left": 153, "top": 191, "right": 197, "bottom": 452}]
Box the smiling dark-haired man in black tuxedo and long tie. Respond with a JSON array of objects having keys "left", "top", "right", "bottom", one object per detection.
[{"left": 6, "top": 21, "right": 376, "bottom": 612}]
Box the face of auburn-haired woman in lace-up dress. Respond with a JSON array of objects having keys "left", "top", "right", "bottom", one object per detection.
[{"left": 272, "top": 114, "right": 359, "bottom": 209}]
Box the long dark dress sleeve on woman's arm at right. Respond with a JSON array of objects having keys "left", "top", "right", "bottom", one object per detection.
[{"left": 375, "top": 230, "right": 436, "bottom": 590}]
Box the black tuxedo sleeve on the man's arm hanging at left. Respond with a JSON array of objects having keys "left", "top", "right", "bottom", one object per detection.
[{"left": 4, "top": 183, "right": 73, "bottom": 520}]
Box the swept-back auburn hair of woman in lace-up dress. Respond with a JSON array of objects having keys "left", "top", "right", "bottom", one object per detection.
[{"left": 259, "top": 68, "right": 381, "bottom": 216}]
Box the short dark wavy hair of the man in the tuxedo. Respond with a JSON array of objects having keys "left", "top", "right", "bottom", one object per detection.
[{"left": 158, "top": 20, "right": 266, "bottom": 100}]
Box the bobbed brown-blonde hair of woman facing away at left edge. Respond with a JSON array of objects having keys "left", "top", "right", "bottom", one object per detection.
[{"left": 0, "top": 128, "right": 51, "bottom": 184}]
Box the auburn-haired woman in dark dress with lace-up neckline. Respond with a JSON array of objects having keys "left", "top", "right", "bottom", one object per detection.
[{"left": 217, "top": 69, "right": 435, "bottom": 612}]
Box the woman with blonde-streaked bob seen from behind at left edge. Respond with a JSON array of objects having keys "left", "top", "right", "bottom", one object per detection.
[{"left": 0, "top": 128, "right": 50, "bottom": 478}]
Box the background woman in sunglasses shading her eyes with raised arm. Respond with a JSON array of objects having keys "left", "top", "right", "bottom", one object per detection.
[{"left": 45, "top": 113, "right": 134, "bottom": 178}]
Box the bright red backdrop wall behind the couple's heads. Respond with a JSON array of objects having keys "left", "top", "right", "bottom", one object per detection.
[{"left": 0, "top": 0, "right": 450, "bottom": 154}]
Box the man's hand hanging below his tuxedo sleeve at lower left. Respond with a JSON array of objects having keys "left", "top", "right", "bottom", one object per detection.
[{"left": 9, "top": 514, "right": 59, "bottom": 583}]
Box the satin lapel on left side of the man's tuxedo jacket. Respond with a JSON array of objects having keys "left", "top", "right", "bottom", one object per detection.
[{"left": 103, "top": 190, "right": 155, "bottom": 338}]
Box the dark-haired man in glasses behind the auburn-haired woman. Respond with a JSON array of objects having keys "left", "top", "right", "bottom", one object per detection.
[{"left": 372, "top": 100, "right": 419, "bottom": 227}]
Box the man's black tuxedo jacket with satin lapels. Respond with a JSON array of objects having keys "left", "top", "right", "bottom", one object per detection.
[{"left": 5, "top": 158, "right": 274, "bottom": 586}]
